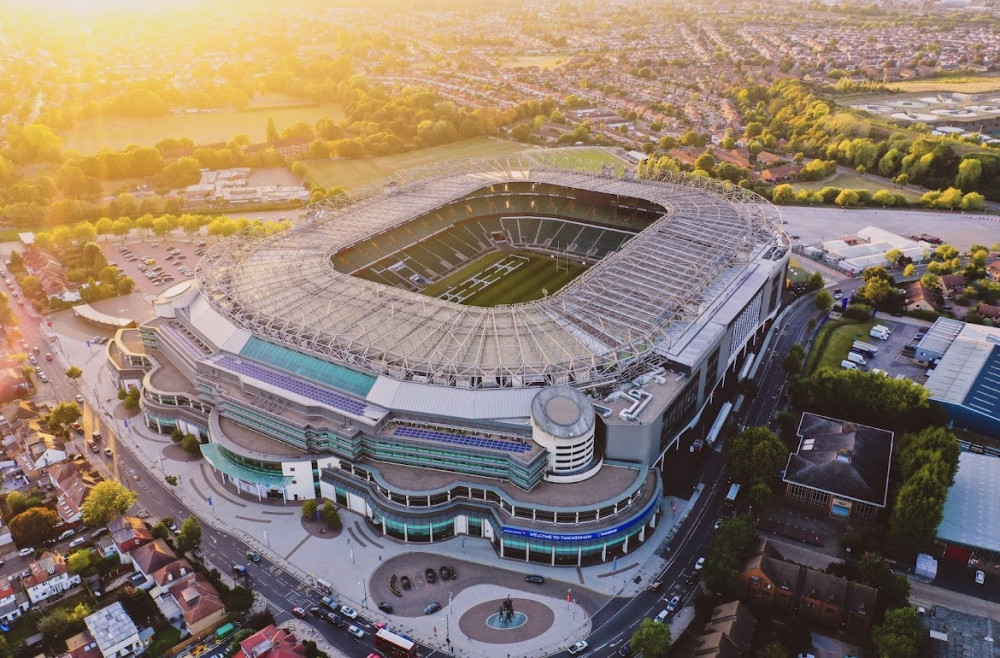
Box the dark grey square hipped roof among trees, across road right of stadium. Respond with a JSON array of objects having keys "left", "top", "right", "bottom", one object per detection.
[{"left": 783, "top": 413, "right": 893, "bottom": 507}]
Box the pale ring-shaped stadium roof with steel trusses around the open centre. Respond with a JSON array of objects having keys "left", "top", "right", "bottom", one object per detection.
[{"left": 197, "top": 156, "right": 780, "bottom": 388}]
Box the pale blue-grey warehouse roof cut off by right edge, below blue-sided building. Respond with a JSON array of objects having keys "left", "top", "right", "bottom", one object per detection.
[{"left": 937, "top": 452, "right": 1000, "bottom": 553}]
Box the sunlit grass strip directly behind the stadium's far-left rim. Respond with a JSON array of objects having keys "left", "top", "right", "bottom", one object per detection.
[{"left": 303, "top": 137, "right": 524, "bottom": 190}]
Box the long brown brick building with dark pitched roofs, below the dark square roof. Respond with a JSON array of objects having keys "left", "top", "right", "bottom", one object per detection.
[{"left": 740, "top": 539, "right": 878, "bottom": 637}]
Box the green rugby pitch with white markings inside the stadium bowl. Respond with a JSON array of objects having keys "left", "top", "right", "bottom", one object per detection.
[{"left": 421, "top": 251, "right": 588, "bottom": 307}]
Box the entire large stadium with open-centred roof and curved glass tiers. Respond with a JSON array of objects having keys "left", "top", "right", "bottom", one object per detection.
[{"left": 108, "top": 155, "right": 789, "bottom": 565}]
